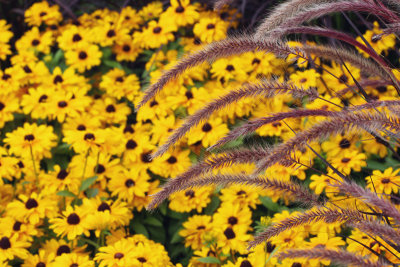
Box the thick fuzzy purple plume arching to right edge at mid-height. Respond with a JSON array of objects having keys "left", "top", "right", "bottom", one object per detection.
[{"left": 254, "top": 112, "right": 400, "bottom": 175}]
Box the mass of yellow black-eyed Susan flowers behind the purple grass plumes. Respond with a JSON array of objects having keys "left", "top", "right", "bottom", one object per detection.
[{"left": 0, "top": 0, "right": 400, "bottom": 267}]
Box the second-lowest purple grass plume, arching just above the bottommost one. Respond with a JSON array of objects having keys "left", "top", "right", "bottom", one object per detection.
[{"left": 249, "top": 208, "right": 366, "bottom": 247}]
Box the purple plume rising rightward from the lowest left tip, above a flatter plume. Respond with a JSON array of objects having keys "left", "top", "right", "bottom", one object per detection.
[{"left": 147, "top": 146, "right": 269, "bottom": 210}]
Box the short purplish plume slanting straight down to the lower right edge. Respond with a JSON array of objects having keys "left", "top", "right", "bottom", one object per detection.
[{"left": 332, "top": 181, "right": 400, "bottom": 223}]
